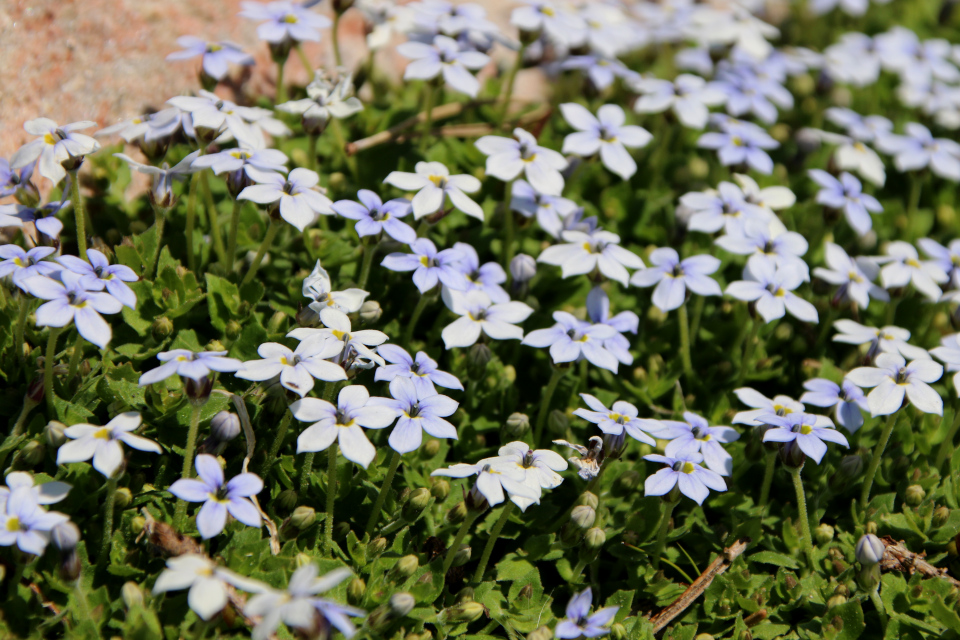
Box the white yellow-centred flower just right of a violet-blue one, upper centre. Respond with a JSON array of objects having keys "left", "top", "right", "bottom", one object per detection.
[{"left": 384, "top": 162, "right": 483, "bottom": 222}]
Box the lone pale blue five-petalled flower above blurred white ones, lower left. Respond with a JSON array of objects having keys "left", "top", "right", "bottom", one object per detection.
[{"left": 169, "top": 453, "right": 263, "bottom": 540}]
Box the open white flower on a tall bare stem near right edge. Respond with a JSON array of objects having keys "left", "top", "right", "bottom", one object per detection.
[{"left": 847, "top": 353, "right": 943, "bottom": 416}]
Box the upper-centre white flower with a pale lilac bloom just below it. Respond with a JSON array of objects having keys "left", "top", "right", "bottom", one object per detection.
[{"left": 476, "top": 128, "right": 567, "bottom": 196}]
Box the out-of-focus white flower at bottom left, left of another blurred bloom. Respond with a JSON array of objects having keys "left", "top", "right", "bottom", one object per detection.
[{"left": 153, "top": 553, "right": 268, "bottom": 620}]
